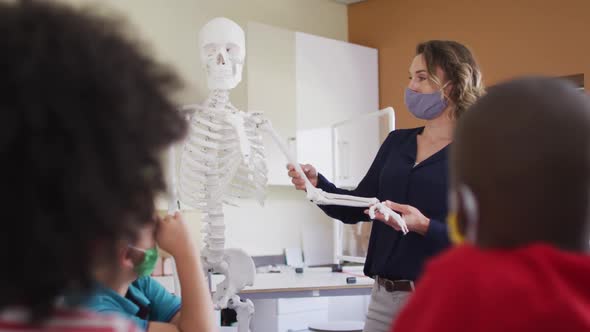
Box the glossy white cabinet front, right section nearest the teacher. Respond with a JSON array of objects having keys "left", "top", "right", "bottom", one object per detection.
[{"left": 295, "top": 32, "right": 380, "bottom": 187}]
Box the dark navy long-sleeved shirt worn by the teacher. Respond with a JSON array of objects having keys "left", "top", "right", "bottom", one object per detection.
[{"left": 318, "top": 127, "right": 449, "bottom": 280}]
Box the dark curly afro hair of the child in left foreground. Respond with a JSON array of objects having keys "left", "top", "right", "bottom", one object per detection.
[{"left": 0, "top": 1, "right": 187, "bottom": 319}]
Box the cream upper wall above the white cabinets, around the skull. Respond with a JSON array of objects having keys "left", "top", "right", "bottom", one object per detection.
[{"left": 62, "top": 0, "right": 348, "bottom": 108}]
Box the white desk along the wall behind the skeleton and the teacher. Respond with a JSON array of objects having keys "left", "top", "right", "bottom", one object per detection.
[{"left": 157, "top": 267, "right": 373, "bottom": 332}]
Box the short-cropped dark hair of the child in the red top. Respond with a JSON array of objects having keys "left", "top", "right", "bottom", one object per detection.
[{"left": 451, "top": 77, "right": 590, "bottom": 251}]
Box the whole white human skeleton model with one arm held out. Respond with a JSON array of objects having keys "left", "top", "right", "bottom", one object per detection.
[{"left": 169, "top": 18, "right": 407, "bottom": 332}]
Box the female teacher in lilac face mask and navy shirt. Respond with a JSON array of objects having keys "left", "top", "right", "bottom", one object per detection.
[{"left": 289, "top": 40, "right": 484, "bottom": 332}]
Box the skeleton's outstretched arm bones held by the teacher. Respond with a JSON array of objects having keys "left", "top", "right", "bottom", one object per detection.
[{"left": 258, "top": 119, "right": 408, "bottom": 234}]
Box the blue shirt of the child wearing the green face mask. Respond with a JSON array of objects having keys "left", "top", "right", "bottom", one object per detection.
[{"left": 84, "top": 277, "right": 180, "bottom": 331}]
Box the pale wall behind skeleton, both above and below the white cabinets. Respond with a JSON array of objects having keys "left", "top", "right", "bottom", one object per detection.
[{"left": 62, "top": 0, "right": 348, "bottom": 255}]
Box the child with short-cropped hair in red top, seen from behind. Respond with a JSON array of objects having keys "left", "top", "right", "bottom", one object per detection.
[{"left": 392, "top": 78, "right": 590, "bottom": 332}]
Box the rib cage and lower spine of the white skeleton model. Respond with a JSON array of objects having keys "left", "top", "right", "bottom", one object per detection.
[{"left": 178, "top": 104, "right": 267, "bottom": 261}]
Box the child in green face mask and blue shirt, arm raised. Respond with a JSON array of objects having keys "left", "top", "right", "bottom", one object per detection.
[{"left": 77, "top": 213, "right": 210, "bottom": 332}]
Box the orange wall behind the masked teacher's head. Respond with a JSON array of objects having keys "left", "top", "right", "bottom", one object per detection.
[{"left": 348, "top": 0, "right": 590, "bottom": 128}]
